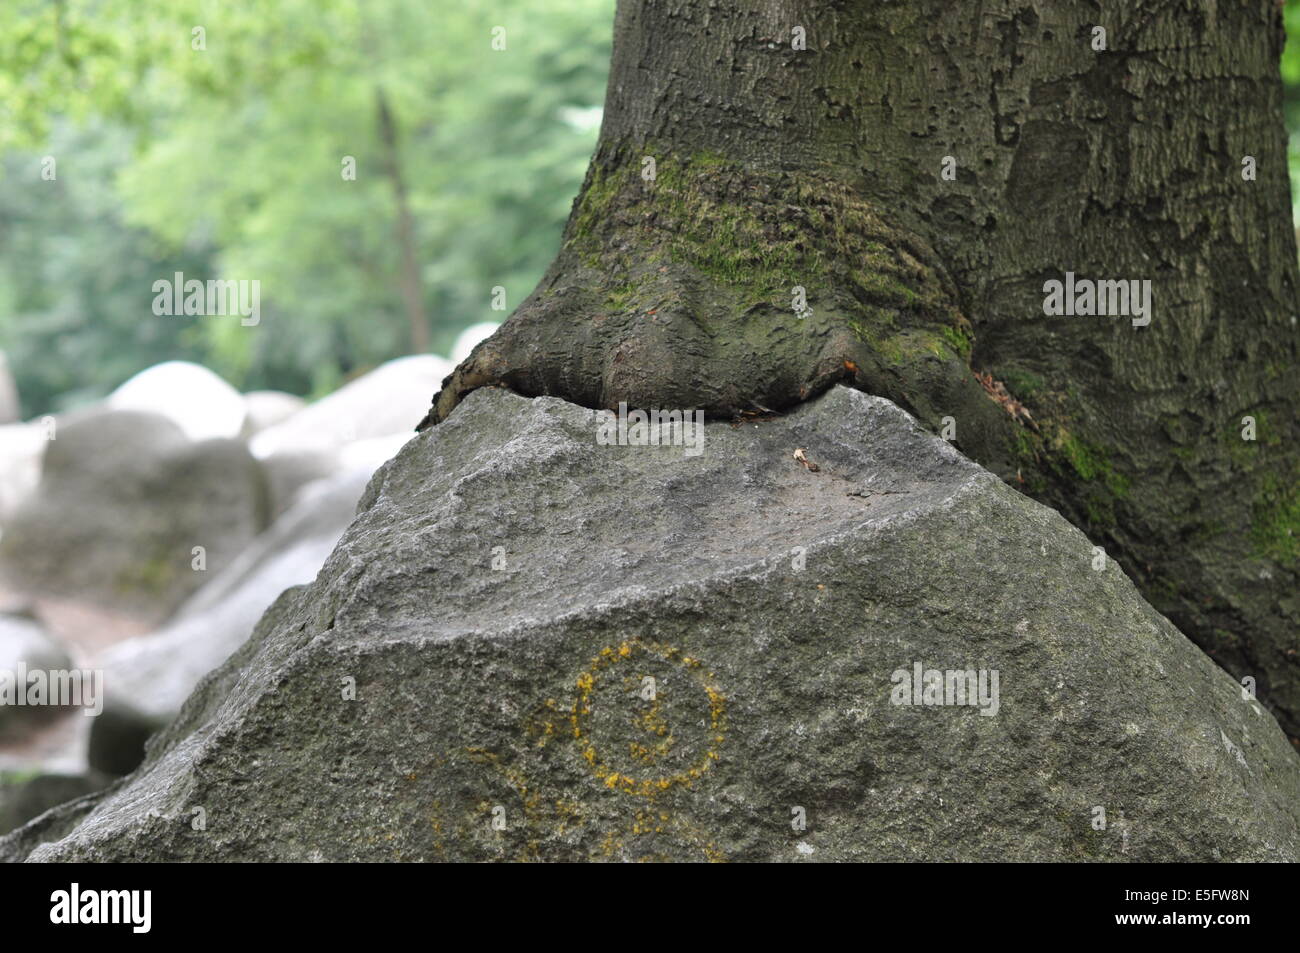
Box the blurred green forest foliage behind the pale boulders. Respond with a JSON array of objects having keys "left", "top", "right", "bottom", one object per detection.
[{"left": 0, "top": 0, "right": 614, "bottom": 416}]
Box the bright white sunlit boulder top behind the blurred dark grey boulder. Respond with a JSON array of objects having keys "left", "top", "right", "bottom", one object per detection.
[{"left": 105, "top": 360, "right": 247, "bottom": 441}]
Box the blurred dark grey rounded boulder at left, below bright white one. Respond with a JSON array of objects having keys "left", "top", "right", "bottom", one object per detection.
[{"left": 0, "top": 410, "right": 268, "bottom": 624}]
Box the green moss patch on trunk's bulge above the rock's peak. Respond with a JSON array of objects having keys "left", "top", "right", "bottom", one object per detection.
[{"left": 566, "top": 147, "right": 970, "bottom": 319}]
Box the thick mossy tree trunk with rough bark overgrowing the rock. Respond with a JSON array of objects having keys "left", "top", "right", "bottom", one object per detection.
[{"left": 425, "top": 0, "right": 1300, "bottom": 735}]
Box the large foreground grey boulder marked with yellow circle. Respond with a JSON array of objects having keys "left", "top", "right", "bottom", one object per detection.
[{"left": 10, "top": 389, "right": 1300, "bottom": 861}]
